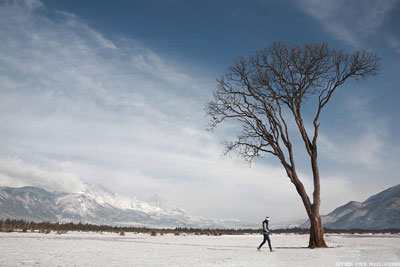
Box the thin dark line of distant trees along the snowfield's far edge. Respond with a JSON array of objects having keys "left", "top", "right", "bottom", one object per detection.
[{"left": 0, "top": 219, "right": 400, "bottom": 236}]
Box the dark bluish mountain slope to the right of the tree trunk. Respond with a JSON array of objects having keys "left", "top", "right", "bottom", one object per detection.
[{"left": 301, "top": 185, "right": 400, "bottom": 229}]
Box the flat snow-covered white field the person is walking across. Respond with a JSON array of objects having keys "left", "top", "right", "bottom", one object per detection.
[{"left": 0, "top": 232, "right": 400, "bottom": 266}]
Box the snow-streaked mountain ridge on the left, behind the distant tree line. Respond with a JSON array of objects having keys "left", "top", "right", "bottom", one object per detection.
[{"left": 0, "top": 185, "right": 259, "bottom": 228}]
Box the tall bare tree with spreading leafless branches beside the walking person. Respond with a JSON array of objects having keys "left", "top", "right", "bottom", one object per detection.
[{"left": 207, "top": 42, "right": 380, "bottom": 248}]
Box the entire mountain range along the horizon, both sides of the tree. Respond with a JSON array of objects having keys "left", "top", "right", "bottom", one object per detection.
[{"left": 0, "top": 184, "right": 400, "bottom": 229}]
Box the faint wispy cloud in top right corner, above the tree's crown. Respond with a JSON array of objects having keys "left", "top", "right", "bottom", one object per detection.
[{"left": 300, "top": 0, "right": 396, "bottom": 47}]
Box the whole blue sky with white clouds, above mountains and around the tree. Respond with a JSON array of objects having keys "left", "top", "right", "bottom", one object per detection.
[{"left": 0, "top": 0, "right": 400, "bottom": 221}]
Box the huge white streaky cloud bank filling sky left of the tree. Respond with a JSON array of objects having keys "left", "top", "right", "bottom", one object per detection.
[{"left": 0, "top": 2, "right": 312, "bottom": 223}]
